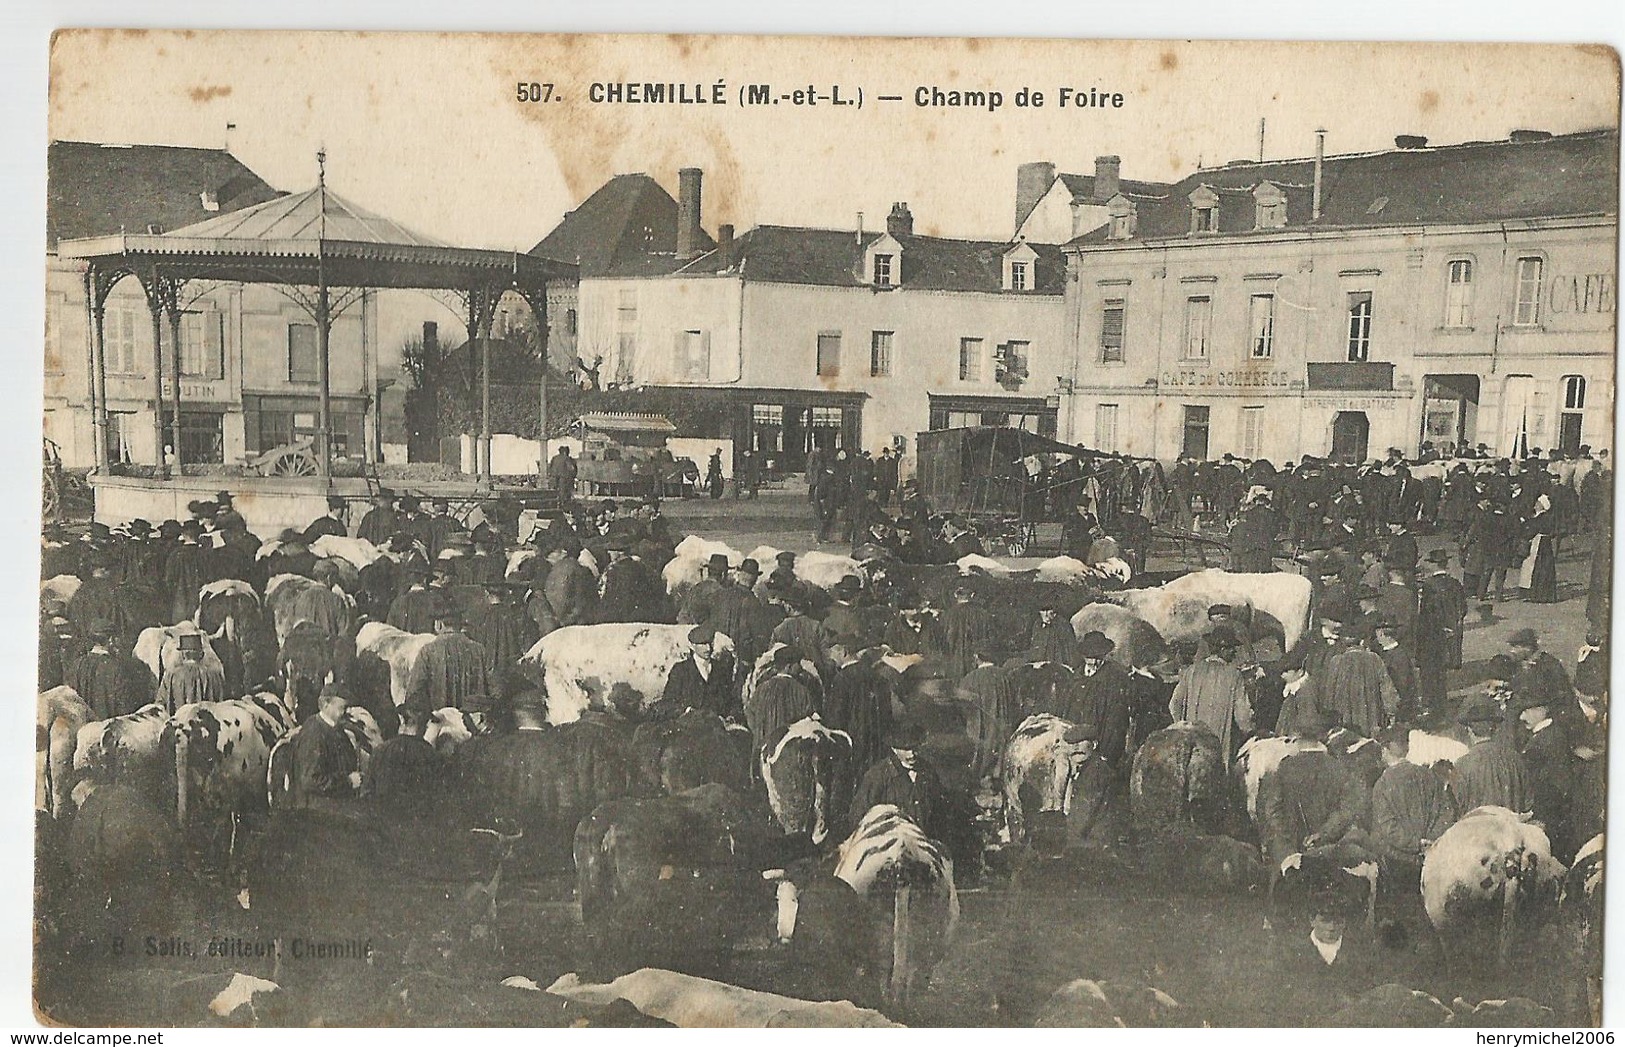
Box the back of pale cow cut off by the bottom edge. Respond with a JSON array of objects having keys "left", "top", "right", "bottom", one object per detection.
[{"left": 546, "top": 967, "right": 902, "bottom": 1029}]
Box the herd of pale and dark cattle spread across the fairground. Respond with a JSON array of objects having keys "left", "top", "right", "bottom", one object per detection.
[{"left": 37, "top": 523, "right": 1602, "bottom": 1024}]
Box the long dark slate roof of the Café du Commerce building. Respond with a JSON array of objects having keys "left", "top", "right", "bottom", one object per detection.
[{"left": 1073, "top": 130, "right": 1619, "bottom": 245}]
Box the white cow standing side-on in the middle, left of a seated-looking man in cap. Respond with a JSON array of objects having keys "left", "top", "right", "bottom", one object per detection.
[{"left": 520, "top": 621, "right": 733, "bottom": 723}]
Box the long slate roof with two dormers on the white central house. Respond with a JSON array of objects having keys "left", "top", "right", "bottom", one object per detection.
[{"left": 683, "top": 226, "right": 1066, "bottom": 294}]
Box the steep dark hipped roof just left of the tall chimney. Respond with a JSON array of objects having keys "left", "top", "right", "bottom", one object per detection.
[{"left": 530, "top": 174, "right": 715, "bottom": 278}]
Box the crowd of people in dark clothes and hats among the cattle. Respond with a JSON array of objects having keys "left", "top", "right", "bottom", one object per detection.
[{"left": 41, "top": 432, "right": 1610, "bottom": 877}]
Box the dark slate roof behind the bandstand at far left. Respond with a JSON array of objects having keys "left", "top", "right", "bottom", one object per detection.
[{"left": 46, "top": 141, "right": 280, "bottom": 250}]
